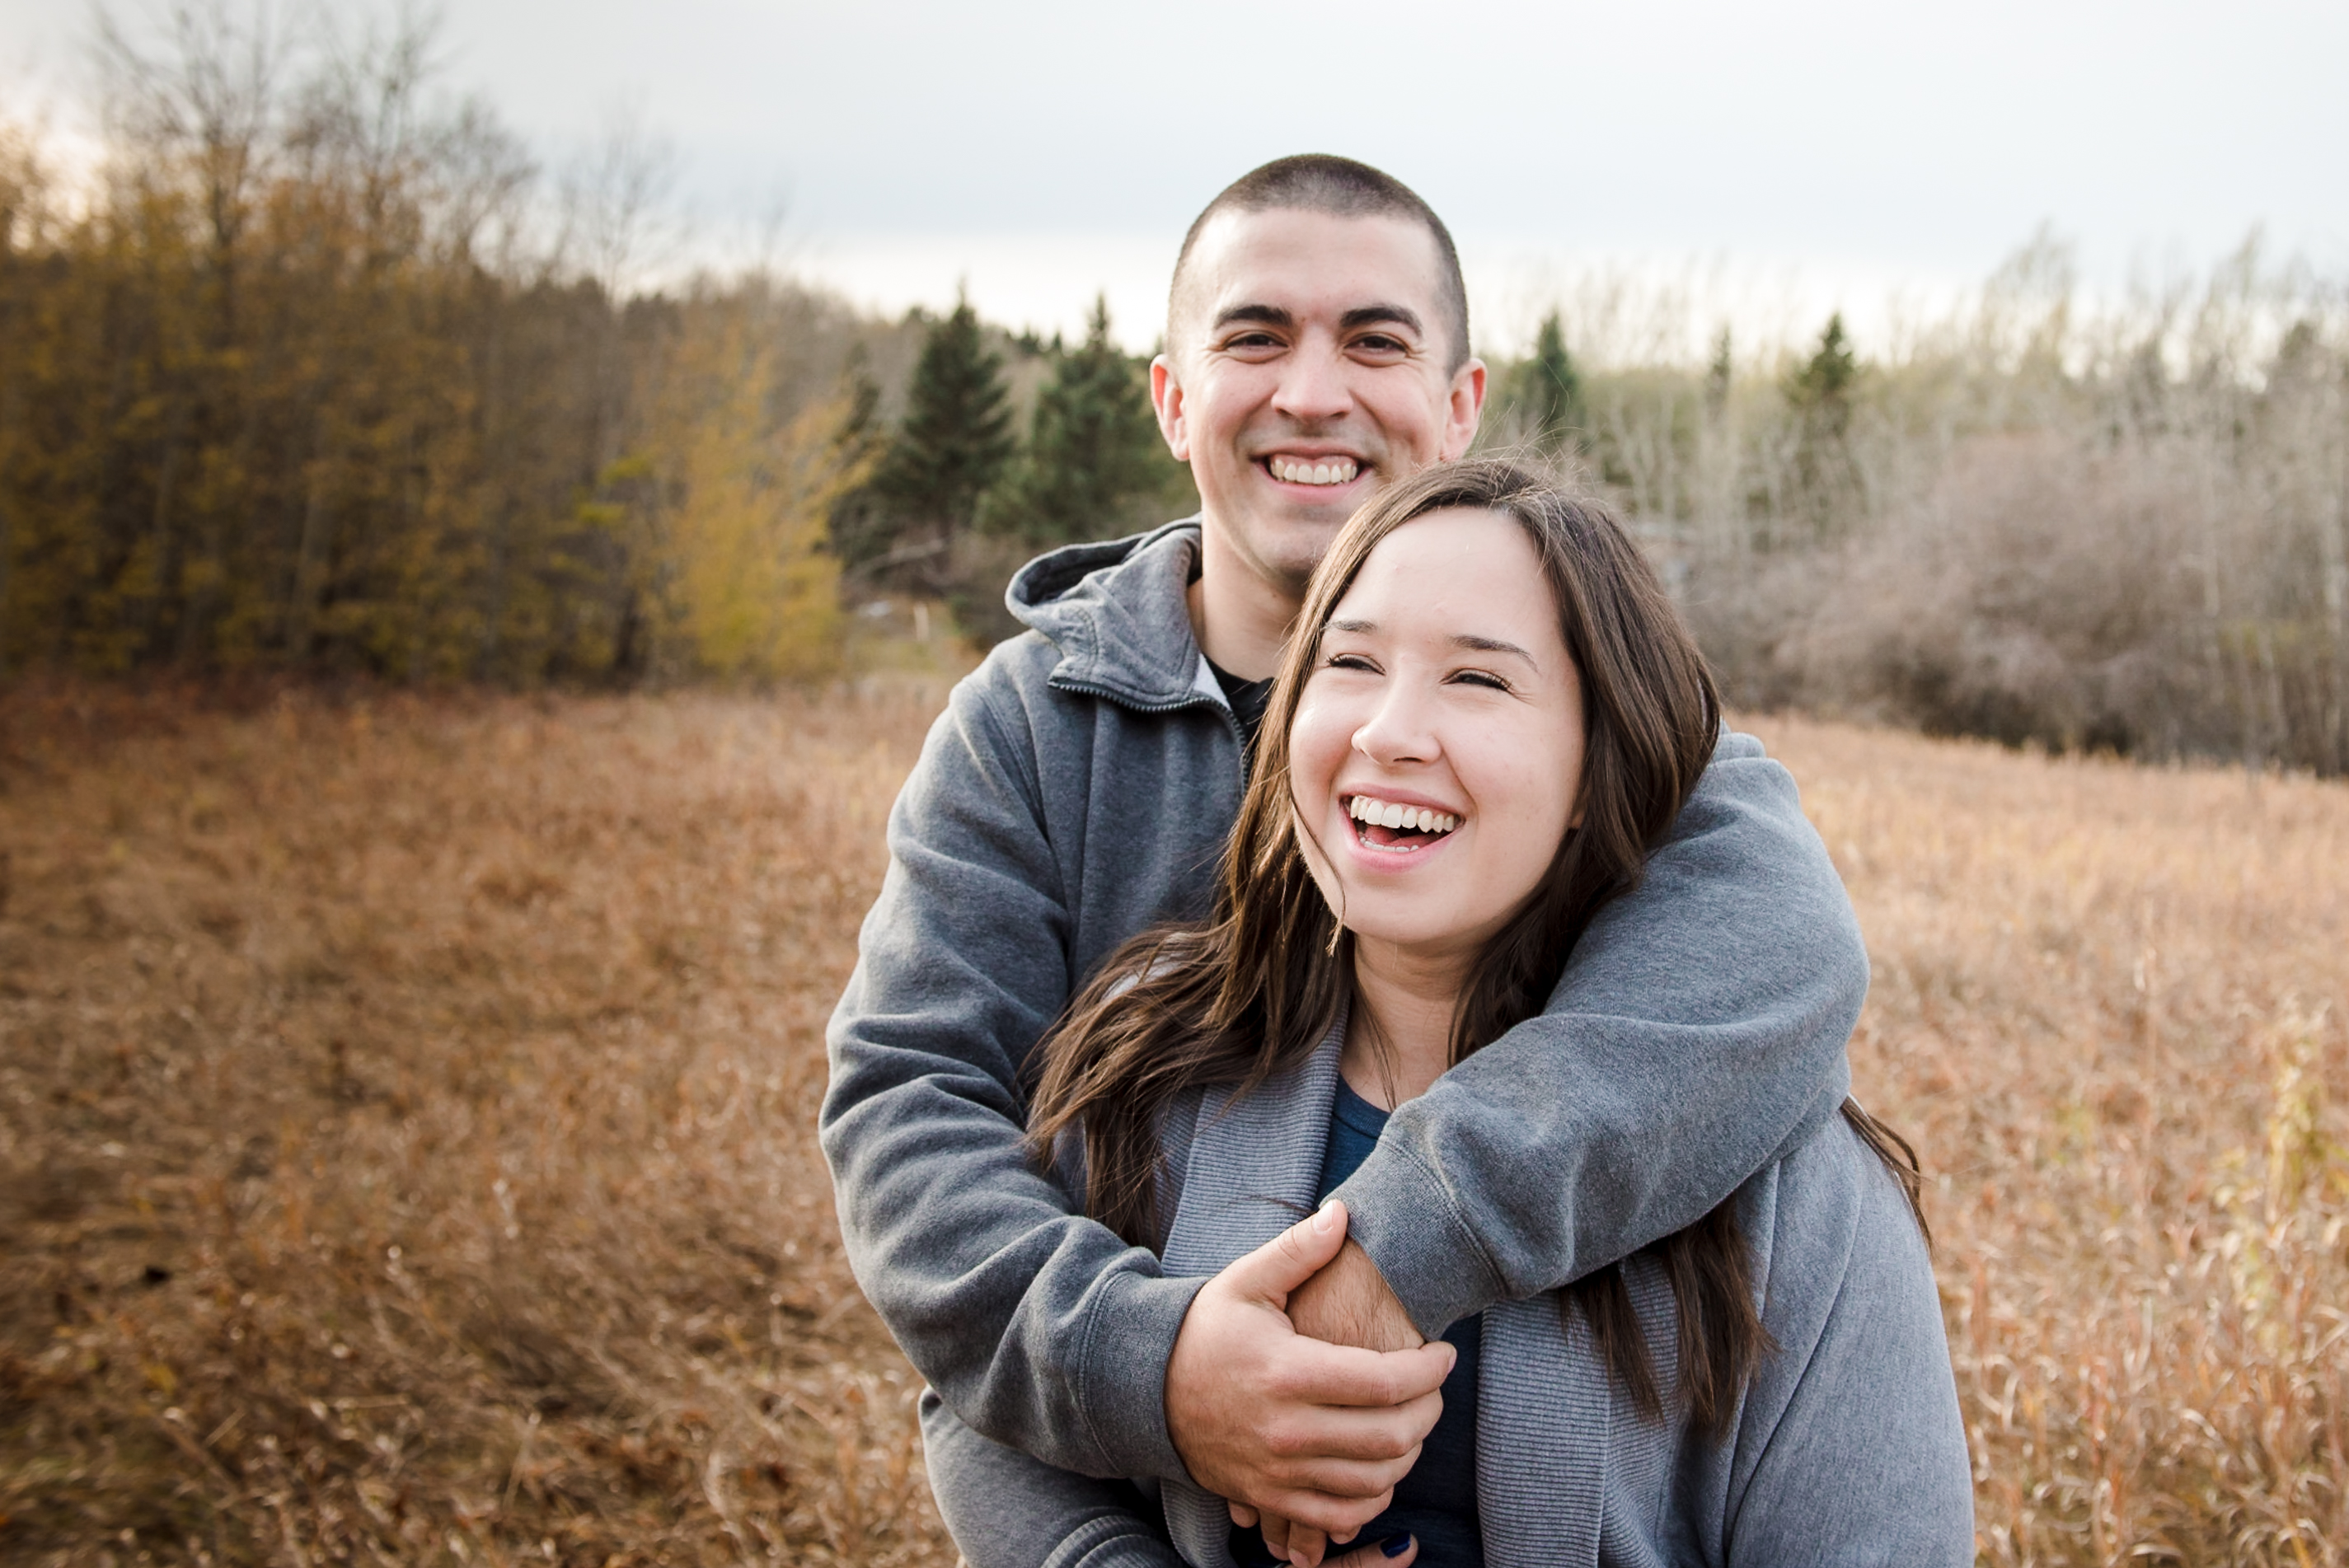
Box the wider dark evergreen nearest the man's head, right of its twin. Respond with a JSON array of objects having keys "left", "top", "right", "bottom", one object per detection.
[{"left": 987, "top": 296, "right": 1174, "bottom": 545}]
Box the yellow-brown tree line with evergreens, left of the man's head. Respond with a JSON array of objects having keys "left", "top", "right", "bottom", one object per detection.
[{"left": 0, "top": 9, "right": 1179, "bottom": 683}]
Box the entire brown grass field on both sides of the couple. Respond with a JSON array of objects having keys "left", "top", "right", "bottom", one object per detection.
[{"left": 0, "top": 678, "right": 2349, "bottom": 1566}]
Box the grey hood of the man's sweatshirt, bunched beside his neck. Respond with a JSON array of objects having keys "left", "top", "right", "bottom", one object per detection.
[{"left": 1003, "top": 517, "right": 1219, "bottom": 711}]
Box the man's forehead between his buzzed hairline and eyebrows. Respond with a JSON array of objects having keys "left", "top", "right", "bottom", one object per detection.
[{"left": 1174, "top": 209, "right": 1442, "bottom": 335}]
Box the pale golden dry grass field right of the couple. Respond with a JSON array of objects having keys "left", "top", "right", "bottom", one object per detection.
[{"left": 1757, "top": 718, "right": 2349, "bottom": 1566}]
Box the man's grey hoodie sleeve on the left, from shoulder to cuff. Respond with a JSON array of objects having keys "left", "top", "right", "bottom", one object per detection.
[{"left": 820, "top": 669, "right": 1203, "bottom": 1477}]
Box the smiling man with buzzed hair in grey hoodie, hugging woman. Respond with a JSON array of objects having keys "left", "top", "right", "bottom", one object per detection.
[{"left": 823, "top": 157, "right": 1868, "bottom": 1538}]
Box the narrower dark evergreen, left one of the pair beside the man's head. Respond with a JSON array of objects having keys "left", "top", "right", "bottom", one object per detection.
[{"left": 874, "top": 298, "right": 1012, "bottom": 551}]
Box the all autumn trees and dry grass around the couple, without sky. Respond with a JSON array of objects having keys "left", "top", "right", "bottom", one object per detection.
[{"left": 0, "top": 7, "right": 2349, "bottom": 1568}]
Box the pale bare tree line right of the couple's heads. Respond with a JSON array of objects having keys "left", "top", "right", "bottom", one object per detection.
[{"left": 1484, "top": 258, "right": 2349, "bottom": 777}]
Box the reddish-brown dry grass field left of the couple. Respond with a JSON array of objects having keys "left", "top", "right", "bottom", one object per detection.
[{"left": 0, "top": 683, "right": 954, "bottom": 1563}]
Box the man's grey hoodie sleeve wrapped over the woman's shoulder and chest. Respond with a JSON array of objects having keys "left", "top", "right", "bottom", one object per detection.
[{"left": 1337, "top": 735, "right": 1868, "bottom": 1336}]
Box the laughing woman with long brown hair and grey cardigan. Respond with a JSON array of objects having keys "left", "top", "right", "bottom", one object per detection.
[{"left": 923, "top": 462, "right": 1973, "bottom": 1568}]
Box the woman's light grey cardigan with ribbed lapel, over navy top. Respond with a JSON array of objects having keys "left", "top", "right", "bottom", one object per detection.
[{"left": 923, "top": 1026, "right": 1973, "bottom": 1568}]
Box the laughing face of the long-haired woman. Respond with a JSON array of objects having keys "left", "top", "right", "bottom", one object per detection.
[{"left": 1290, "top": 509, "right": 1583, "bottom": 957}]
